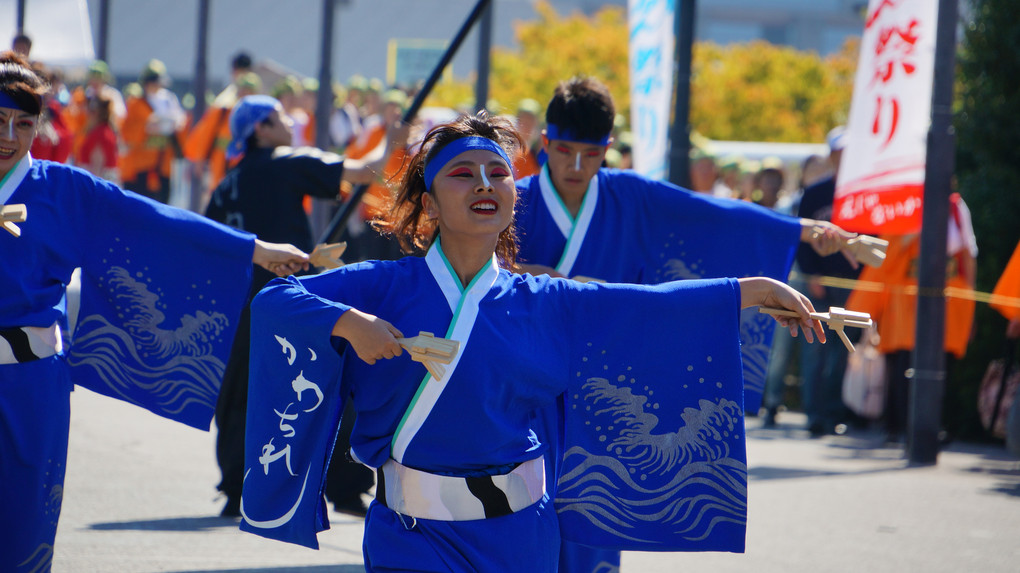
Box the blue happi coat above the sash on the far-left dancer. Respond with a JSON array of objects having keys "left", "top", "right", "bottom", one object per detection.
[{"left": 0, "top": 157, "right": 255, "bottom": 429}]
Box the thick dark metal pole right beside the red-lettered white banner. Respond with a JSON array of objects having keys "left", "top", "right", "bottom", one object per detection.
[{"left": 907, "top": 0, "right": 958, "bottom": 465}]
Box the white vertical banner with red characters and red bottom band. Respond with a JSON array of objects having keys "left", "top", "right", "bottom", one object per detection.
[{"left": 832, "top": 0, "right": 938, "bottom": 235}]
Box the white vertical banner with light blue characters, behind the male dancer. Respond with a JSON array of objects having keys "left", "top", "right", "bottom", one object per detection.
[{"left": 627, "top": 0, "right": 675, "bottom": 179}]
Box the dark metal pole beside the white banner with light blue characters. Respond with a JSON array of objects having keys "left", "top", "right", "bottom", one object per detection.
[{"left": 669, "top": 0, "right": 697, "bottom": 188}]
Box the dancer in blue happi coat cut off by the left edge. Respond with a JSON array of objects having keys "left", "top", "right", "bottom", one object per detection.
[{"left": 0, "top": 52, "right": 307, "bottom": 571}]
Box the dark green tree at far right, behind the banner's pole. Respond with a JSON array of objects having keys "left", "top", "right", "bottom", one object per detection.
[{"left": 945, "top": 0, "right": 1020, "bottom": 437}]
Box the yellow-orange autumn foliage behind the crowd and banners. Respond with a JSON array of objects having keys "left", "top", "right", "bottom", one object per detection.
[{"left": 429, "top": 2, "right": 863, "bottom": 142}]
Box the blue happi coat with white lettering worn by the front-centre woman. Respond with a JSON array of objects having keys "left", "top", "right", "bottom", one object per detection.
[{"left": 242, "top": 244, "right": 747, "bottom": 571}]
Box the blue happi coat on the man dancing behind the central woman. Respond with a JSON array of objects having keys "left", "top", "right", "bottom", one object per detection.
[{"left": 515, "top": 166, "right": 801, "bottom": 412}]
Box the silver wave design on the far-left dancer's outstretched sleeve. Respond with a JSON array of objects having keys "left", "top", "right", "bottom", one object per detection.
[{"left": 68, "top": 267, "right": 228, "bottom": 414}]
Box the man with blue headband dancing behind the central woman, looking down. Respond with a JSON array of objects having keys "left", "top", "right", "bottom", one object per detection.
[{"left": 516, "top": 77, "right": 873, "bottom": 573}]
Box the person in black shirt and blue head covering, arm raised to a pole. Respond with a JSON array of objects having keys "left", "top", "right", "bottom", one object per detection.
[{"left": 205, "top": 95, "right": 408, "bottom": 517}]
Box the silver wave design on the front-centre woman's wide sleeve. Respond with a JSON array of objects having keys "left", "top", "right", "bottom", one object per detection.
[{"left": 556, "top": 378, "right": 747, "bottom": 541}]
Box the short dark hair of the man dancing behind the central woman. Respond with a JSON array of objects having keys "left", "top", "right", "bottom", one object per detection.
[{"left": 546, "top": 77, "right": 616, "bottom": 140}]
